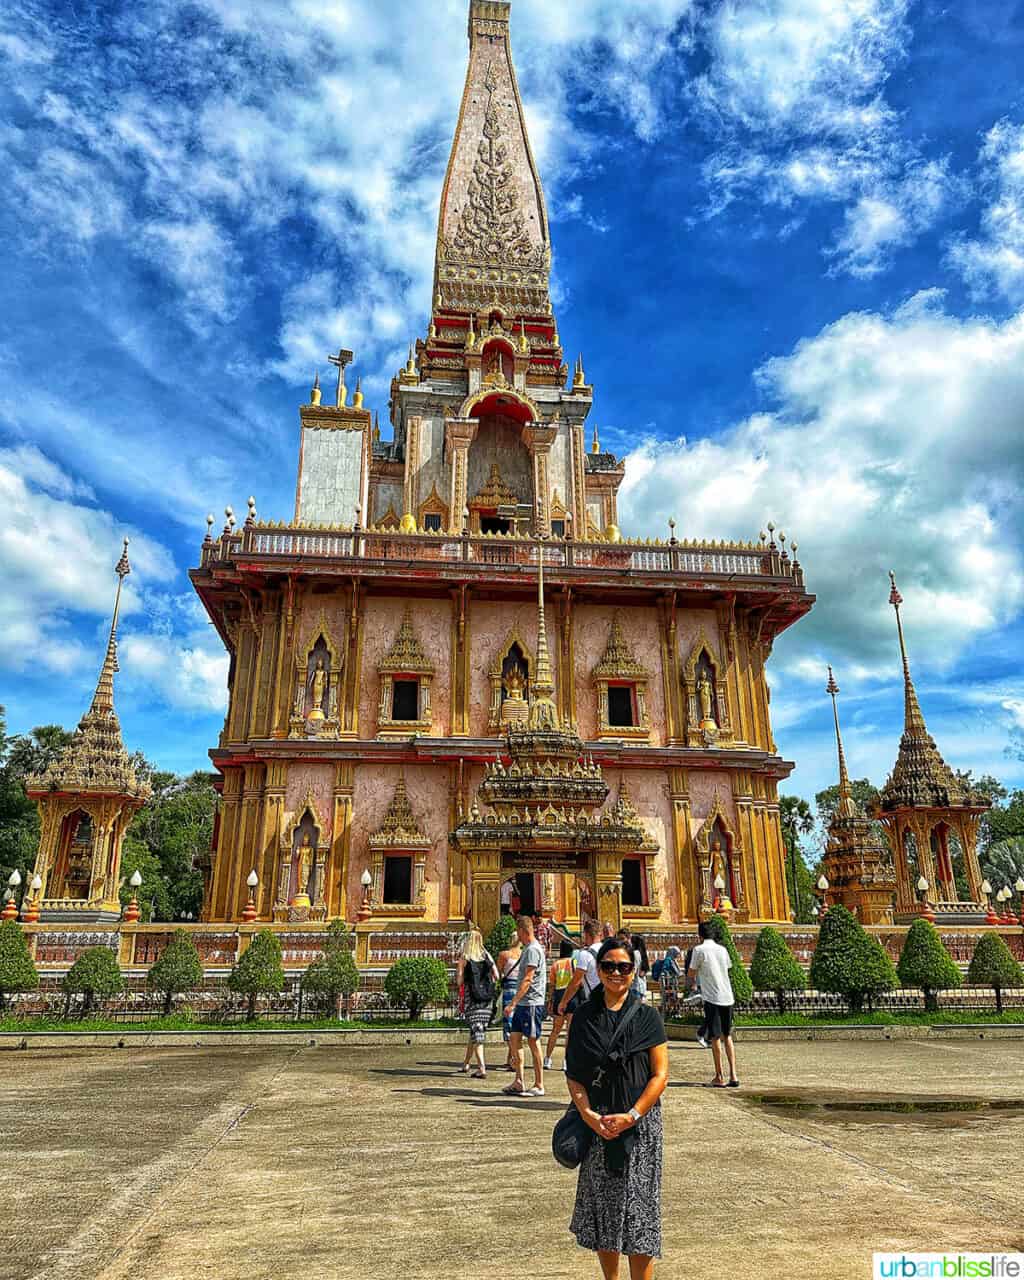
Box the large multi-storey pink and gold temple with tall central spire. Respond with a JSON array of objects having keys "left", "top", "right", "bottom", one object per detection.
[{"left": 191, "top": 0, "right": 813, "bottom": 929}]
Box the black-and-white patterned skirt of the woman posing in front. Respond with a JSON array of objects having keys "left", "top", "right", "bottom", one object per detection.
[{"left": 570, "top": 1103, "right": 663, "bottom": 1258}]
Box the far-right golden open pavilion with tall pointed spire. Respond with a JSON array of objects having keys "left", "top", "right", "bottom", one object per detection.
[{"left": 876, "top": 573, "right": 991, "bottom": 924}]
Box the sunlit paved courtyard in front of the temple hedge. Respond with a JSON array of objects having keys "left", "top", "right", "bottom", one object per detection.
[{"left": 0, "top": 1041, "right": 1024, "bottom": 1280}]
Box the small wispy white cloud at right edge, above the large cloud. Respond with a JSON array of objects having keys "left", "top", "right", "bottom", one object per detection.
[{"left": 950, "top": 119, "right": 1024, "bottom": 305}]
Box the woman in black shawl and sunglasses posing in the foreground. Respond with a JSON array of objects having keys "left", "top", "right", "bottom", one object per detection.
[{"left": 566, "top": 938, "right": 668, "bottom": 1280}]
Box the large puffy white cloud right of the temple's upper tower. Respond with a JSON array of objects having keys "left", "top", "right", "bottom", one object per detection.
[{"left": 621, "top": 292, "right": 1024, "bottom": 677}]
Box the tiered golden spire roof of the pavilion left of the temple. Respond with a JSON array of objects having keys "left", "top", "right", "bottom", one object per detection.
[{"left": 26, "top": 538, "right": 151, "bottom": 800}]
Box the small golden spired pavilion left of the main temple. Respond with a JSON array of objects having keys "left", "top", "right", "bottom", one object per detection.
[{"left": 23, "top": 538, "right": 150, "bottom": 924}]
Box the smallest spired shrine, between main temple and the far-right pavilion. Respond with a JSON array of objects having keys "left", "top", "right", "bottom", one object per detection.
[{"left": 822, "top": 667, "right": 896, "bottom": 924}]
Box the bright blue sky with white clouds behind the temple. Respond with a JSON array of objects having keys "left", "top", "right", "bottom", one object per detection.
[{"left": 0, "top": 0, "right": 1024, "bottom": 795}]
